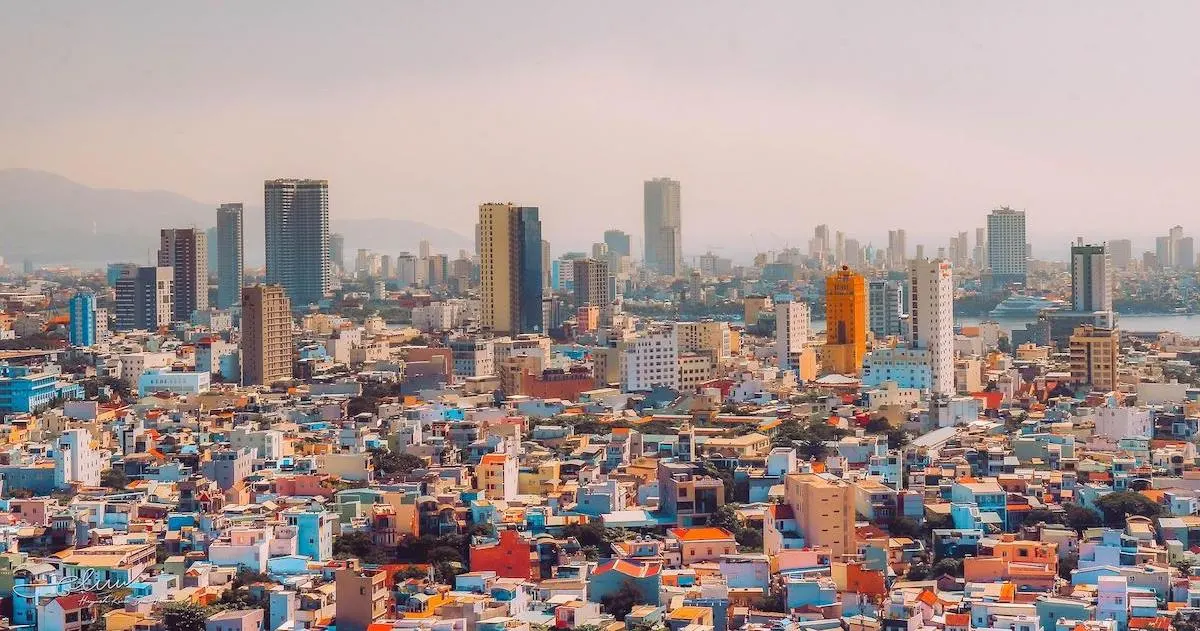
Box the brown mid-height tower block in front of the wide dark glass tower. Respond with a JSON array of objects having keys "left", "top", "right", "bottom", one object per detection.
[{"left": 241, "top": 284, "right": 293, "bottom": 385}]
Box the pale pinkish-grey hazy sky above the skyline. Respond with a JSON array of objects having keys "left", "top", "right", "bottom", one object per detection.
[{"left": 0, "top": 0, "right": 1200, "bottom": 260}]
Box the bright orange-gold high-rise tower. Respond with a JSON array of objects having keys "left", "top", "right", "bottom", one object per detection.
[{"left": 824, "top": 265, "right": 868, "bottom": 374}]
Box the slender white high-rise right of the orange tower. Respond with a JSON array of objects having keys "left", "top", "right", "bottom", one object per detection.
[{"left": 908, "top": 256, "right": 955, "bottom": 396}]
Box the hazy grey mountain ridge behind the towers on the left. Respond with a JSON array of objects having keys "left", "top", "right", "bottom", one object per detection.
[{"left": 0, "top": 169, "right": 474, "bottom": 266}]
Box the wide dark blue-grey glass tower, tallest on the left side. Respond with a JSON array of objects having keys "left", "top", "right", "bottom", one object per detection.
[{"left": 263, "top": 179, "right": 330, "bottom": 306}]
